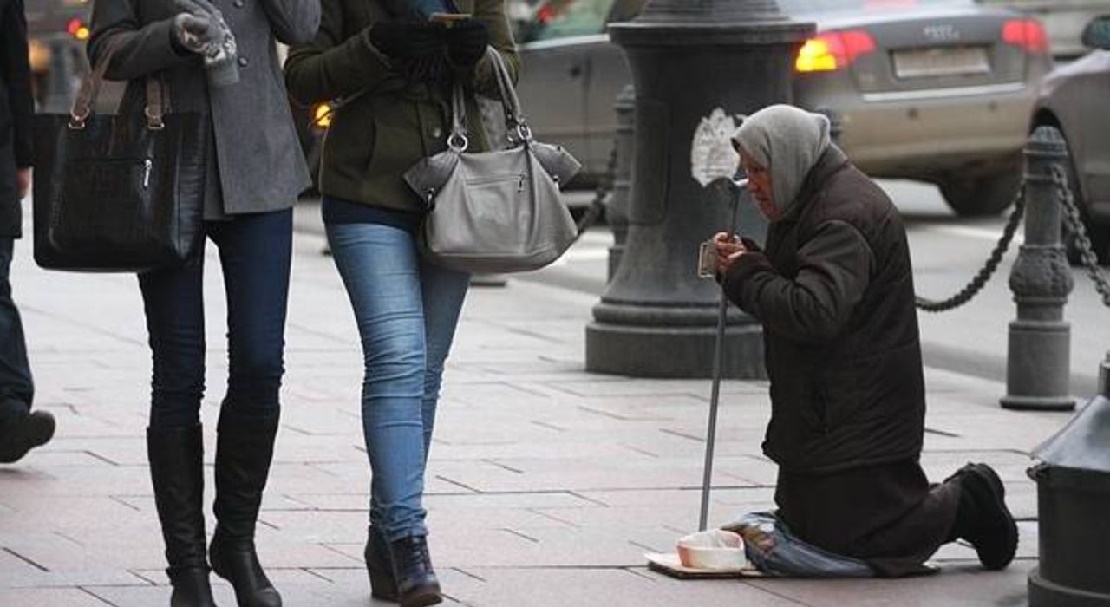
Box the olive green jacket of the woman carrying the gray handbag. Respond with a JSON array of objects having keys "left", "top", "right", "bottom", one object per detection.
[{"left": 285, "top": 0, "right": 515, "bottom": 212}]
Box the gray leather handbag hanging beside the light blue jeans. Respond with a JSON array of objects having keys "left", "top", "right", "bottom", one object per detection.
[{"left": 404, "top": 48, "right": 582, "bottom": 273}]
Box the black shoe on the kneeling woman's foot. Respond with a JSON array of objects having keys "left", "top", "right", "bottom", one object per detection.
[{"left": 953, "top": 464, "right": 1018, "bottom": 570}]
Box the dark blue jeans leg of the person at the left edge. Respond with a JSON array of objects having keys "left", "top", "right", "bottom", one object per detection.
[{"left": 0, "top": 236, "right": 34, "bottom": 434}]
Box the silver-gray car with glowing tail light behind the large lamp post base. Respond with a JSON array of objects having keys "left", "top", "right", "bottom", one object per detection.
[{"left": 517, "top": 0, "right": 1052, "bottom": 215}]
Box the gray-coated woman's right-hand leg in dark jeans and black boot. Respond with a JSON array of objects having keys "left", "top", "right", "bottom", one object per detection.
[{"left": 210, "top": 210, "right": 292, "bottom": 607}]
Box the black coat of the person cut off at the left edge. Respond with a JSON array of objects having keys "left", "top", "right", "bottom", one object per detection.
[{"left": 0, "top": 0, "right": 34, "bottom": 237}]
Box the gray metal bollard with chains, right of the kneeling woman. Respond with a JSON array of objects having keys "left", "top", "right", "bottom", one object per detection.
[{"left": 1000, "top": 127, "right": 1076, "bottom": 411}]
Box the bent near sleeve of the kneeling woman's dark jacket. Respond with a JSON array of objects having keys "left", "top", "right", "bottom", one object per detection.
[{"left": 724, "top": 221, "right": 875, "bottom": 343}]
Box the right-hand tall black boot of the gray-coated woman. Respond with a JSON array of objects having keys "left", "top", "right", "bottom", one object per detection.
[{"left": 209, "top": 417, "right": 282, "bottom": 607}]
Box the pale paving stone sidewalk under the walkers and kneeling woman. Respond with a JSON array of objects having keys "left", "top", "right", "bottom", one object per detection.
[{"left": 0, "top": 206, "right": 1068, "bottom": 607}]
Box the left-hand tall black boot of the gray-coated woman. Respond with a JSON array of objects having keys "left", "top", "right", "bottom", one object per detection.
[{"left": 147, "top": 425, "right": 215, "bottom": 607}]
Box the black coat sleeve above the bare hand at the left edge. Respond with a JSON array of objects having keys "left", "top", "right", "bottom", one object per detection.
[{"left": 0, "top": 0, "right": 34, "bottom": 169}]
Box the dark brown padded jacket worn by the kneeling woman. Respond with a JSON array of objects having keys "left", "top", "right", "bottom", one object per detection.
[{"left": 724, "top": 146, "right": 925, "bottom": 473}]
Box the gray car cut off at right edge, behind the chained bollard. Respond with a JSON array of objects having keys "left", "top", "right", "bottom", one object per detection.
[{"left": 1031, "top": 17, "right": 1110, "bottom": 264}]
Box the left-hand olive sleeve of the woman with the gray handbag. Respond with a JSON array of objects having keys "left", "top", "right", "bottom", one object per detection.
[{"left": 285, "top": 0, "right": 393, "bottom": 105}]
